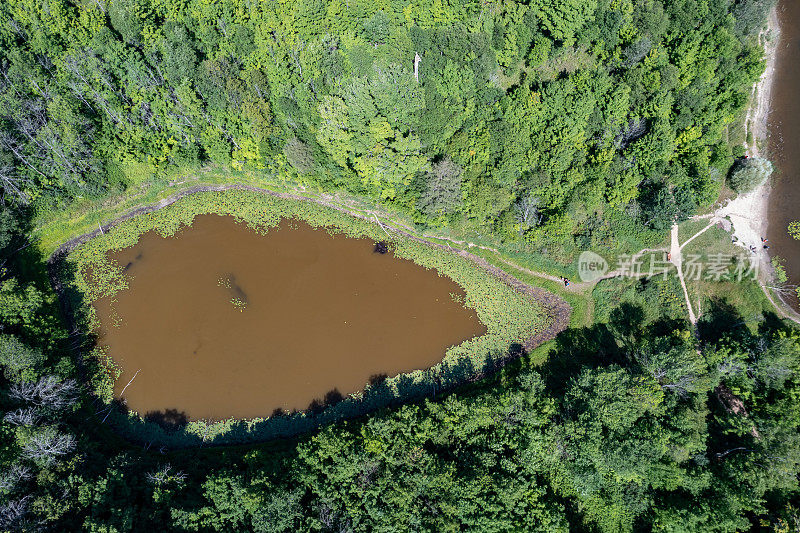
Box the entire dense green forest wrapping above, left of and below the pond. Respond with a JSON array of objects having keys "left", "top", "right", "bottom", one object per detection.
[{"left": 0, "top": 0, "right": 800, "bottom": 531}]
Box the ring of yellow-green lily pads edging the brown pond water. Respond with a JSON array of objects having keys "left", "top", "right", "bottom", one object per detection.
[{"left": 62, "top": 190, "right": 551, "bottom": 447}]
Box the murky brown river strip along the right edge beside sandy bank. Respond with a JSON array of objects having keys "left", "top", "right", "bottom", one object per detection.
[{"left": 767, "top": 0, "right": 800, "bottom": 309}]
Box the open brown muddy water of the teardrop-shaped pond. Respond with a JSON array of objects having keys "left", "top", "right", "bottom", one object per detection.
[{"left": 95, "top": 215, "right": 486, "bottom": 420}]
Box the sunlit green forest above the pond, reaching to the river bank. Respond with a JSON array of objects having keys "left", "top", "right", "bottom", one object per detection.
[{"left": 0, "top": 0, "right": 770, "bottom": 262}]
